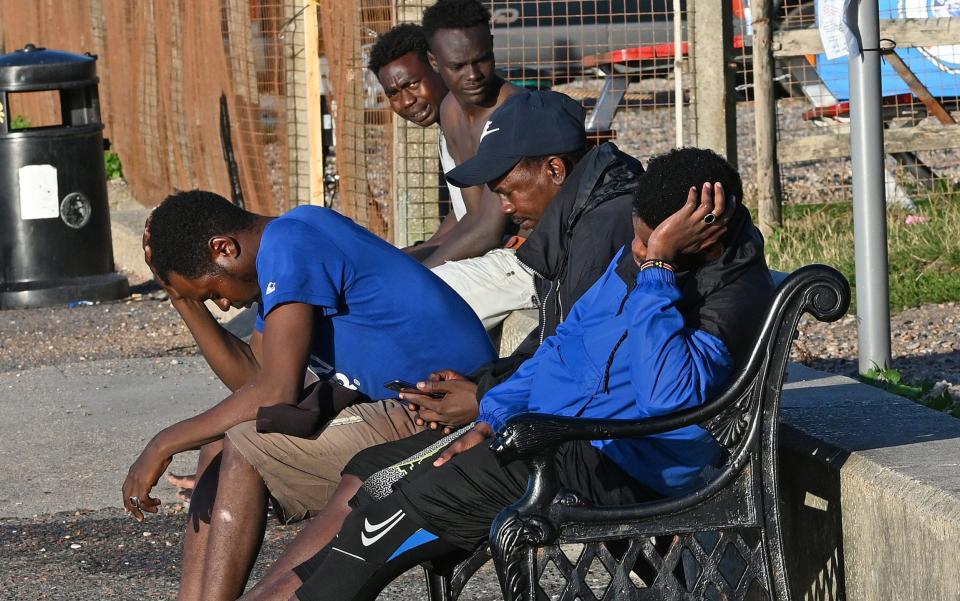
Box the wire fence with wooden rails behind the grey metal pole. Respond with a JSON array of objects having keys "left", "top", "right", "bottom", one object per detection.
[{"left": 776, "top": 0, "right": 960, "bottom": 206}]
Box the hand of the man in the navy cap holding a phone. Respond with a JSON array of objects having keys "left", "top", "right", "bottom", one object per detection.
[{"left": 400, "top": 369, "right": 480, "bottom": 434}]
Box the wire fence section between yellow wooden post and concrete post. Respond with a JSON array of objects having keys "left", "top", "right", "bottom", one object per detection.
[{"left": 321, "top": 0, "right": 696, "bottom": 245}]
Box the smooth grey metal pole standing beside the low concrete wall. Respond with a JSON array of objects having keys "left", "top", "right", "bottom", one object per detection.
[{"left": 847, "top": 0, "right": 890, "bottom": 373}]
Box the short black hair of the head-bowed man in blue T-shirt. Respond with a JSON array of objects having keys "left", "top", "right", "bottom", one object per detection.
[{"left": 144, "top": 190, "right": 257, "bottom": 284}]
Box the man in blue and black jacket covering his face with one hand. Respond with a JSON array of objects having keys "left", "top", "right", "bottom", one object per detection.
[{"left": 248, "top": 148, "right": 773, "bottom": 601}]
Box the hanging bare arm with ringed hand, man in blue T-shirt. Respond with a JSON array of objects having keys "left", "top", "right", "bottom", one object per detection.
[{"left": 122, "top": 303, "right": 314, "bottom": 520}]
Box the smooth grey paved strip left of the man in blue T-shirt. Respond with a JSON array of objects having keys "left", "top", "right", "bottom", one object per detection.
[{"left": 0, "top": 357, "right": 219, "bottom": 517}]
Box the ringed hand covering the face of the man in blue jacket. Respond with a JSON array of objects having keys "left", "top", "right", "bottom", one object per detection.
[{"left": 647, "top": 182, "right": 737, "bottom": 261}]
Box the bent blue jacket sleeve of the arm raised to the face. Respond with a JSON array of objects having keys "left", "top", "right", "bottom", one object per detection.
[{"left": 624, "top": 269, "right": 734, "bottom": 417}]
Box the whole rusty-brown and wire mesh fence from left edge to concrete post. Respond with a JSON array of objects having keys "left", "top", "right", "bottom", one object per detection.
[{"left": 0, "top": 0, "right": 696, "bottom": 245}]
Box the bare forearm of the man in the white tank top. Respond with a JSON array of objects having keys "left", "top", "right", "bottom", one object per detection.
[{"left": 423, "top": 186, "right": 507, "bottom": 267}]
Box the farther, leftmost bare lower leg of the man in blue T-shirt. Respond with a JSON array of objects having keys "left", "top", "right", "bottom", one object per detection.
[{"left": 177, "top": 441, "right": 223, "bottom": 601}]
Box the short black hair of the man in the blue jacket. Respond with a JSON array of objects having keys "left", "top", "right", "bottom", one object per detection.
[{"left": 633, "top": 148, "right": 743, "bottom": 229}]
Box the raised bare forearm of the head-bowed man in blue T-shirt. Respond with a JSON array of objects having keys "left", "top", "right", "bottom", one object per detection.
[{"left": 170, "top": 296, "right": 260, "bottom": 392}]
